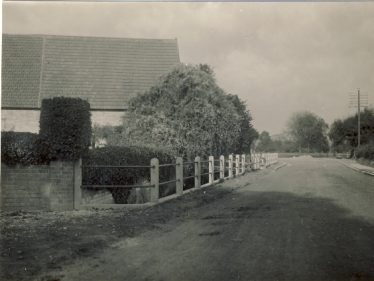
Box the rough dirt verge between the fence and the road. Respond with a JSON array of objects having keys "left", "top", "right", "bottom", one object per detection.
[{"left": 0, "top": 170, "right": 269, "bottom": 280}]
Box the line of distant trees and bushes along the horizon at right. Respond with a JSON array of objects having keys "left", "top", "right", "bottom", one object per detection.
[{"left": 255, "top": 108, "right": 374, "bottom": 156}]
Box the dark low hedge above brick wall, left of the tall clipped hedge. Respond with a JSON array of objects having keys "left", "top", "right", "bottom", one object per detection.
[{"left": 1, "top": 132, "right": 44, "bottom": 166}]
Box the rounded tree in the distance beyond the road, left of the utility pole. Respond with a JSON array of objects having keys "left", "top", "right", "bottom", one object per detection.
[{"left": 288, "top": 111, "right": 329, "bottom": 153}]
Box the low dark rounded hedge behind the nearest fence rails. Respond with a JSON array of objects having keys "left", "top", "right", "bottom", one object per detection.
[{"left": 83, "top": 146, "right": 175, "bottom": 203}]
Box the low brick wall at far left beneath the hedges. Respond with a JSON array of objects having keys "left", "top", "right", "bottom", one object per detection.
[{"left": 1, "top": 161, "right": 76, "bottom": 211}]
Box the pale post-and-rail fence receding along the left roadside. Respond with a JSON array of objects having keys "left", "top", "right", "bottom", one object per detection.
[{"left": 81, "top": 153, "right": 278, "bottom": 205}]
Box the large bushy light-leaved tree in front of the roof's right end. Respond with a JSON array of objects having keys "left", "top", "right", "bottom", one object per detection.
[{"left": 111, "top": 65, "right": 256, "bottom": 159}]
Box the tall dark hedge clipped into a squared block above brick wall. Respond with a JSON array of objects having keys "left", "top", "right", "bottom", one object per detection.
[{"left": 39, "top": 97, "right": 92, "bottom": 160}]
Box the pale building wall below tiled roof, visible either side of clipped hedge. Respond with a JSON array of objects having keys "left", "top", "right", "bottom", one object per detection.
[{"left": 1, "top": 109, "right": 124, "bottom": 133}]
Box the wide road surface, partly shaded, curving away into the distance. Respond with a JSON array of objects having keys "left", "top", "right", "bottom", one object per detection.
[{"left": 38, "top": 157, "right": 374, "bottom": 281}]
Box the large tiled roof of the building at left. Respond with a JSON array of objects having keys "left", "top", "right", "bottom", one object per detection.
[{"left": 2, "top": 35, "right": 179, "bottom": 110}]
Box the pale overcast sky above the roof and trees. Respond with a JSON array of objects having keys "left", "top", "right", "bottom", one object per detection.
[{"left": 3, "top": 2, "right": 374, "bottom": 134}]
